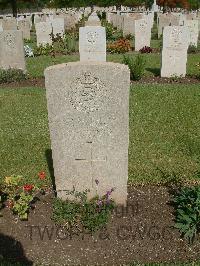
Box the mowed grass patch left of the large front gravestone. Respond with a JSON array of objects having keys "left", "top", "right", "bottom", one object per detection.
[{"left": 0, "top": 88, "right": 50, "bottom": 185}]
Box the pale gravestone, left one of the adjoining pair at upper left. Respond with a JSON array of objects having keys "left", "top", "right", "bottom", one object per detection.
[{"left": 35, "top": 22, "right": 52, "bottom": 46}]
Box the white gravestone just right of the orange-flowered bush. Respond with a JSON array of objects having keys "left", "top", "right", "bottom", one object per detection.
[{"left": 135, "top": 19, "right": 151, "bottom": 51}]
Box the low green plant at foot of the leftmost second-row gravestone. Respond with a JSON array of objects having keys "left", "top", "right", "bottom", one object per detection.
[{"left": 0, "top": 68, "right": 27, "bottom": 84}]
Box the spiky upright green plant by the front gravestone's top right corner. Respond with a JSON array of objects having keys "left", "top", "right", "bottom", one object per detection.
[{"left": 123, "top": 54, "right": 146, "bottom": 80}]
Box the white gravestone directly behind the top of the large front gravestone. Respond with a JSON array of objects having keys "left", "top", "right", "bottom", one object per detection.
[{"left": 79, "top": 26, "right": 106, "bottom": 62}]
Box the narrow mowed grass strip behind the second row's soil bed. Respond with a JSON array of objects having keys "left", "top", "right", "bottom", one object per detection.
[{"left": 26, "top": 52, "right": 200, "bottom": 78}]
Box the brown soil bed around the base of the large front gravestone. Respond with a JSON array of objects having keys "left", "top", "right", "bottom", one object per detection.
[{"left": 0, "top": 187, "right": 200, "bottom": 265}]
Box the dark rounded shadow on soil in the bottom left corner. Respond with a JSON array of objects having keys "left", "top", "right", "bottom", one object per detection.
[{"left": 0, "top": 234, "right": 33, "bottom": 266}]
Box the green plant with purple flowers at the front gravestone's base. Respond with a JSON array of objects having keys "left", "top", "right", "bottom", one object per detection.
[{"left": 52, "top": 183, "right": 115, "bottom": 232}]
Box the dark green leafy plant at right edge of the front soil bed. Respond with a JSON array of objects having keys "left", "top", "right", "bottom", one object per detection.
[{"left": 173, "top": 186, "right": 200, "bottom": 243}]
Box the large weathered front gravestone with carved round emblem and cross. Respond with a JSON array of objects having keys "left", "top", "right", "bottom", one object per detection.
[{"left": 45, "top": 62, "right": 130, "bottom": 204}]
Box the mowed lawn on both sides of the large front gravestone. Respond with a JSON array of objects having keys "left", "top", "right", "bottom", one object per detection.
[{"left": 0, "top": 84, "right": 200, "bottom": 185}]
